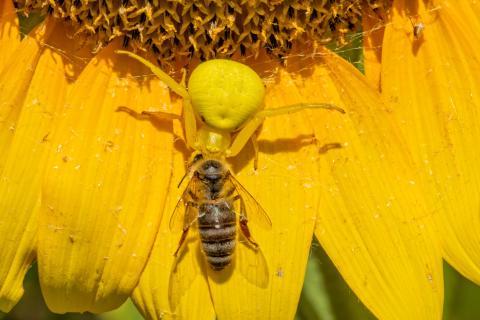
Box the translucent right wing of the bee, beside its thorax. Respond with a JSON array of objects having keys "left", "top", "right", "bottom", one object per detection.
[{"left": 229, "top": 174, "right": 272, "bottom": 229}]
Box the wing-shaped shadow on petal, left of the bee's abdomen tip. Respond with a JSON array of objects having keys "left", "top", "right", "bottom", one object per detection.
[{"left": 168, "top": 225, "right": 203, "bottom": 311}]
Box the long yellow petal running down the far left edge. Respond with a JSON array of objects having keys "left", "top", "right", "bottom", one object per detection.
[{"left": 0, "top": 18, "right": 67, "bottom": 311}]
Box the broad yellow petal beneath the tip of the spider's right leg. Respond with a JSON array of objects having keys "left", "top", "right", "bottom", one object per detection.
[{"left": 302, "top": 50, "right": 443, "bottom": 319}]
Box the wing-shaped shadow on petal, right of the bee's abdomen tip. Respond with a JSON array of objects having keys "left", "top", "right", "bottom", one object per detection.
[{"left": 235, "top": 235, "right": 269, "bottom": 288}]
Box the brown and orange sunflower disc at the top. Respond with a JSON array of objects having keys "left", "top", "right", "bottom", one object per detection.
[{"left": 15, "top": 0, "right": 392, "bottom": 64}]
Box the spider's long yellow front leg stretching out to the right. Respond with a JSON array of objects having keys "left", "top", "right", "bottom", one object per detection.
[{"left": 226, "top": 103, "right": 345, "bottom": 157}]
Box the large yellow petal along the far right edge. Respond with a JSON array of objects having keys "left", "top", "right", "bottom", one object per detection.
[{"left": 382, "top": 0, "right": 480, "bottom": 283}]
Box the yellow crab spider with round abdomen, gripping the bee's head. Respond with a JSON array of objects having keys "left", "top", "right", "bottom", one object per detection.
[{"left": 117, "top": 50, "right": 345, "bottom": 164}]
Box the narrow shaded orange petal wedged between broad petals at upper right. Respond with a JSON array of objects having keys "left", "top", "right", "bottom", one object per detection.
[{"left": 362, "top": 6, "right": 385, "bottom": 89}]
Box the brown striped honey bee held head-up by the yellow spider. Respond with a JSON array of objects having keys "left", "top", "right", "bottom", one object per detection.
[{"left": 170, "top": 153, "right": 272, "bottom": 271}]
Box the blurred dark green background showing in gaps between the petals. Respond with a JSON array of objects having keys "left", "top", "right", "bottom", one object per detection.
[{"left": 0, "top": 14, "right": 480, "bottom": 320}]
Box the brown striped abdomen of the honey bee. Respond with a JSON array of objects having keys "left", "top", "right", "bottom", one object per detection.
[{"left": 198, "top": 200, "right": 236, "bottom": 270}]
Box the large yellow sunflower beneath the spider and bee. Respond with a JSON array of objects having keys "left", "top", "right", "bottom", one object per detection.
[{"left": 0, "top": 0, "right": 480, "bottom": 319}]
